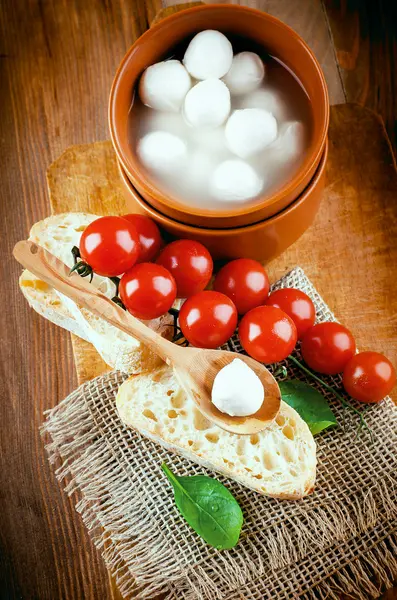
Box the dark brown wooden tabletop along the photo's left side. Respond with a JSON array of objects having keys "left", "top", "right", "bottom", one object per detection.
[{"left": 0, "top": 0, "right": 147, "bottom": 600}]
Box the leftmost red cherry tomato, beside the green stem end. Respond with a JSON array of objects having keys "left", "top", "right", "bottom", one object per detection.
[{"left": 79, "top": 217, "right": 139, "bottom": 277}]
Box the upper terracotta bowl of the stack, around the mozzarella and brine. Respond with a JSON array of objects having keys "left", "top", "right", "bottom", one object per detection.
[{"left": 109, "top": 4, "right": 329, "bottom": 228}]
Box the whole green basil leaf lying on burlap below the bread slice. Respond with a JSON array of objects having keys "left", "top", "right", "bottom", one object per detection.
[{"left": 161, "top": 463, "right": 243, "bottom": 550}]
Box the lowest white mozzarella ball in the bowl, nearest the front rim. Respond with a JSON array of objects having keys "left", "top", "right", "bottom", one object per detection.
[{"left": 210, "top": 159, "right": 263, "bottom": 202}]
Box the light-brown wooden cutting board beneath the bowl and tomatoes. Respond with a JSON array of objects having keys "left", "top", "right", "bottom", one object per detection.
[{"left": 47, "top": 104, "right": 397, "bottom": 390}]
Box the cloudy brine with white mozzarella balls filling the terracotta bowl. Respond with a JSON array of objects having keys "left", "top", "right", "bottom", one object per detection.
[{"left": 129, "top": 32, "right": 312, "bottom": 211}]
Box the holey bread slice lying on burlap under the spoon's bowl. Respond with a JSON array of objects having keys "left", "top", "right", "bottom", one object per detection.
[{"left": 116, "top": 366, "right": 316, "bottom": 500}]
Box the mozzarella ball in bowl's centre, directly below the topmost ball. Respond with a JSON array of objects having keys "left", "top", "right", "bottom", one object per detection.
[{"left": 183, "top": 79, "right": 230, "bottom": 128}]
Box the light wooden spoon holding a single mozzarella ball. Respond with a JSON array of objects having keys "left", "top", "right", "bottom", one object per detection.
[{"left": 14, "top": 241, "right": 280, "bottom": 434}]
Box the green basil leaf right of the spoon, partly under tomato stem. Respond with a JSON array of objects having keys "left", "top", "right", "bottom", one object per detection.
[{"left": 279, "top": 379, "right": 338, "bottom": 435}]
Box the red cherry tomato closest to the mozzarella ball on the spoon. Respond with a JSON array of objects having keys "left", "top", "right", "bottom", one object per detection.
[{"left": 238, "top": 306, "right": 297, "bottom": 364}]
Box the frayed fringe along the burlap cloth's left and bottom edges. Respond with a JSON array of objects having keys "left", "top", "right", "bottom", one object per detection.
[{"left": 43, "top": 372, "right": 397, "bottom": 600}]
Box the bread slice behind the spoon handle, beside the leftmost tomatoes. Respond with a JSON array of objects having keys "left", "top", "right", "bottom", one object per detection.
[{"left": 19, "top": 213, "right": 172, "bottom": 373}]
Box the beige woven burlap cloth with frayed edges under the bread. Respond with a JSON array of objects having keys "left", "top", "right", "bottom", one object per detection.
[{"left": 43, "top": 268, "right": 397, "bottom": 600}]
